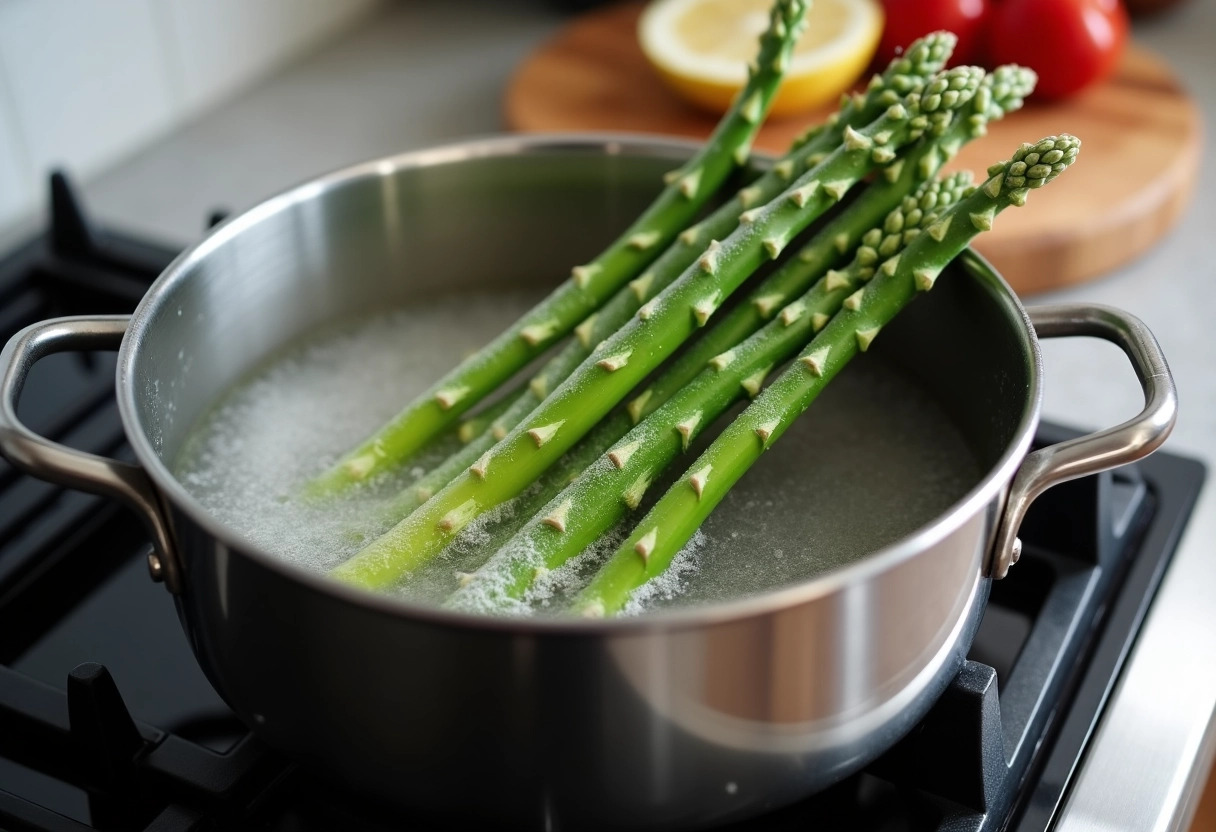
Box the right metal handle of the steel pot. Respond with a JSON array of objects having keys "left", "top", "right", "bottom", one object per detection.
[{"left": 990, "top": 303, "right": 1178, "bottom": 579}]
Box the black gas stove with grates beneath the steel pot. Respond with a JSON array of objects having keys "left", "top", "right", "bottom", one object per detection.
[{"left": 0, "top": 174, "right": 1205, "bottom": 832}]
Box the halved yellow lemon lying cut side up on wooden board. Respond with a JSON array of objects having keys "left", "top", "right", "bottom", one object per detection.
[{"left": 638, "top": 0, "right": 883, "bottom": 116}]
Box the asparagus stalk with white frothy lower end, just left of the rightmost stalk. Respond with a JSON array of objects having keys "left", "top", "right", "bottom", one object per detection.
[{"left": 450, "top": 174, "right": 970, "bottom": 608}]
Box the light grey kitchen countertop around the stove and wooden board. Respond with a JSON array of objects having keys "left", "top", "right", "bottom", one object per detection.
[{"left": 30, "top": 0, "right": 1216, "bottom": 830}]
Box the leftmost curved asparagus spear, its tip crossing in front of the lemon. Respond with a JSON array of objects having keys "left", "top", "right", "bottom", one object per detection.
[{"left": 306, "top": 0, "right": 807, "bottom": 495}]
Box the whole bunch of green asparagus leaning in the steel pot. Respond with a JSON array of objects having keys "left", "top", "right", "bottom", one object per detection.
[{"left": 309, "top": 9, "right": 1079, "bottom": 615}]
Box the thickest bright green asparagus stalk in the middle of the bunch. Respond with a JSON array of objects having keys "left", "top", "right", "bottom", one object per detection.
[{"left": 332, "top": 67, "right": 983, "bottom": 588}]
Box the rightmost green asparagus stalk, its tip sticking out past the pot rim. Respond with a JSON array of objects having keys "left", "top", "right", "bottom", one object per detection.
[{"left": 575, "top": 135, "right": 1080, "bottom": 615}]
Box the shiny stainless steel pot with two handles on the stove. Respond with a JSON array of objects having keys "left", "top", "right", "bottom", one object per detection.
[{"left": 0, "top": 136, "right": 1176, "bottom": 828}]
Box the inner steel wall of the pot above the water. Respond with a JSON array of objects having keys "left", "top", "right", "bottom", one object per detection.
[{"left": 120, "top": 139, "right": 1035, "bottom": 610}]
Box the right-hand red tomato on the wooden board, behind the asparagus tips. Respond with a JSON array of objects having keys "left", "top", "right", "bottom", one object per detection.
[{"left": 987, "top": 0, "right": 1127, "bottom": 99}]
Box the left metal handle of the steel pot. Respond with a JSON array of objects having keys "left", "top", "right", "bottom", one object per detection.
[{"left": 0, "top": 315, "right": 181, "bottom": 594}]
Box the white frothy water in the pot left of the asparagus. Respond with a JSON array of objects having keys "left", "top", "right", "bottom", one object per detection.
[{"left": 176, "top": 293, "right": 542, "bottom": 570}]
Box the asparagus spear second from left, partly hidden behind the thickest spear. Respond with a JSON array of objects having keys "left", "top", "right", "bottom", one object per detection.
[{"left": 364, "top": 32, "right": 956, "bottom": 522}]
